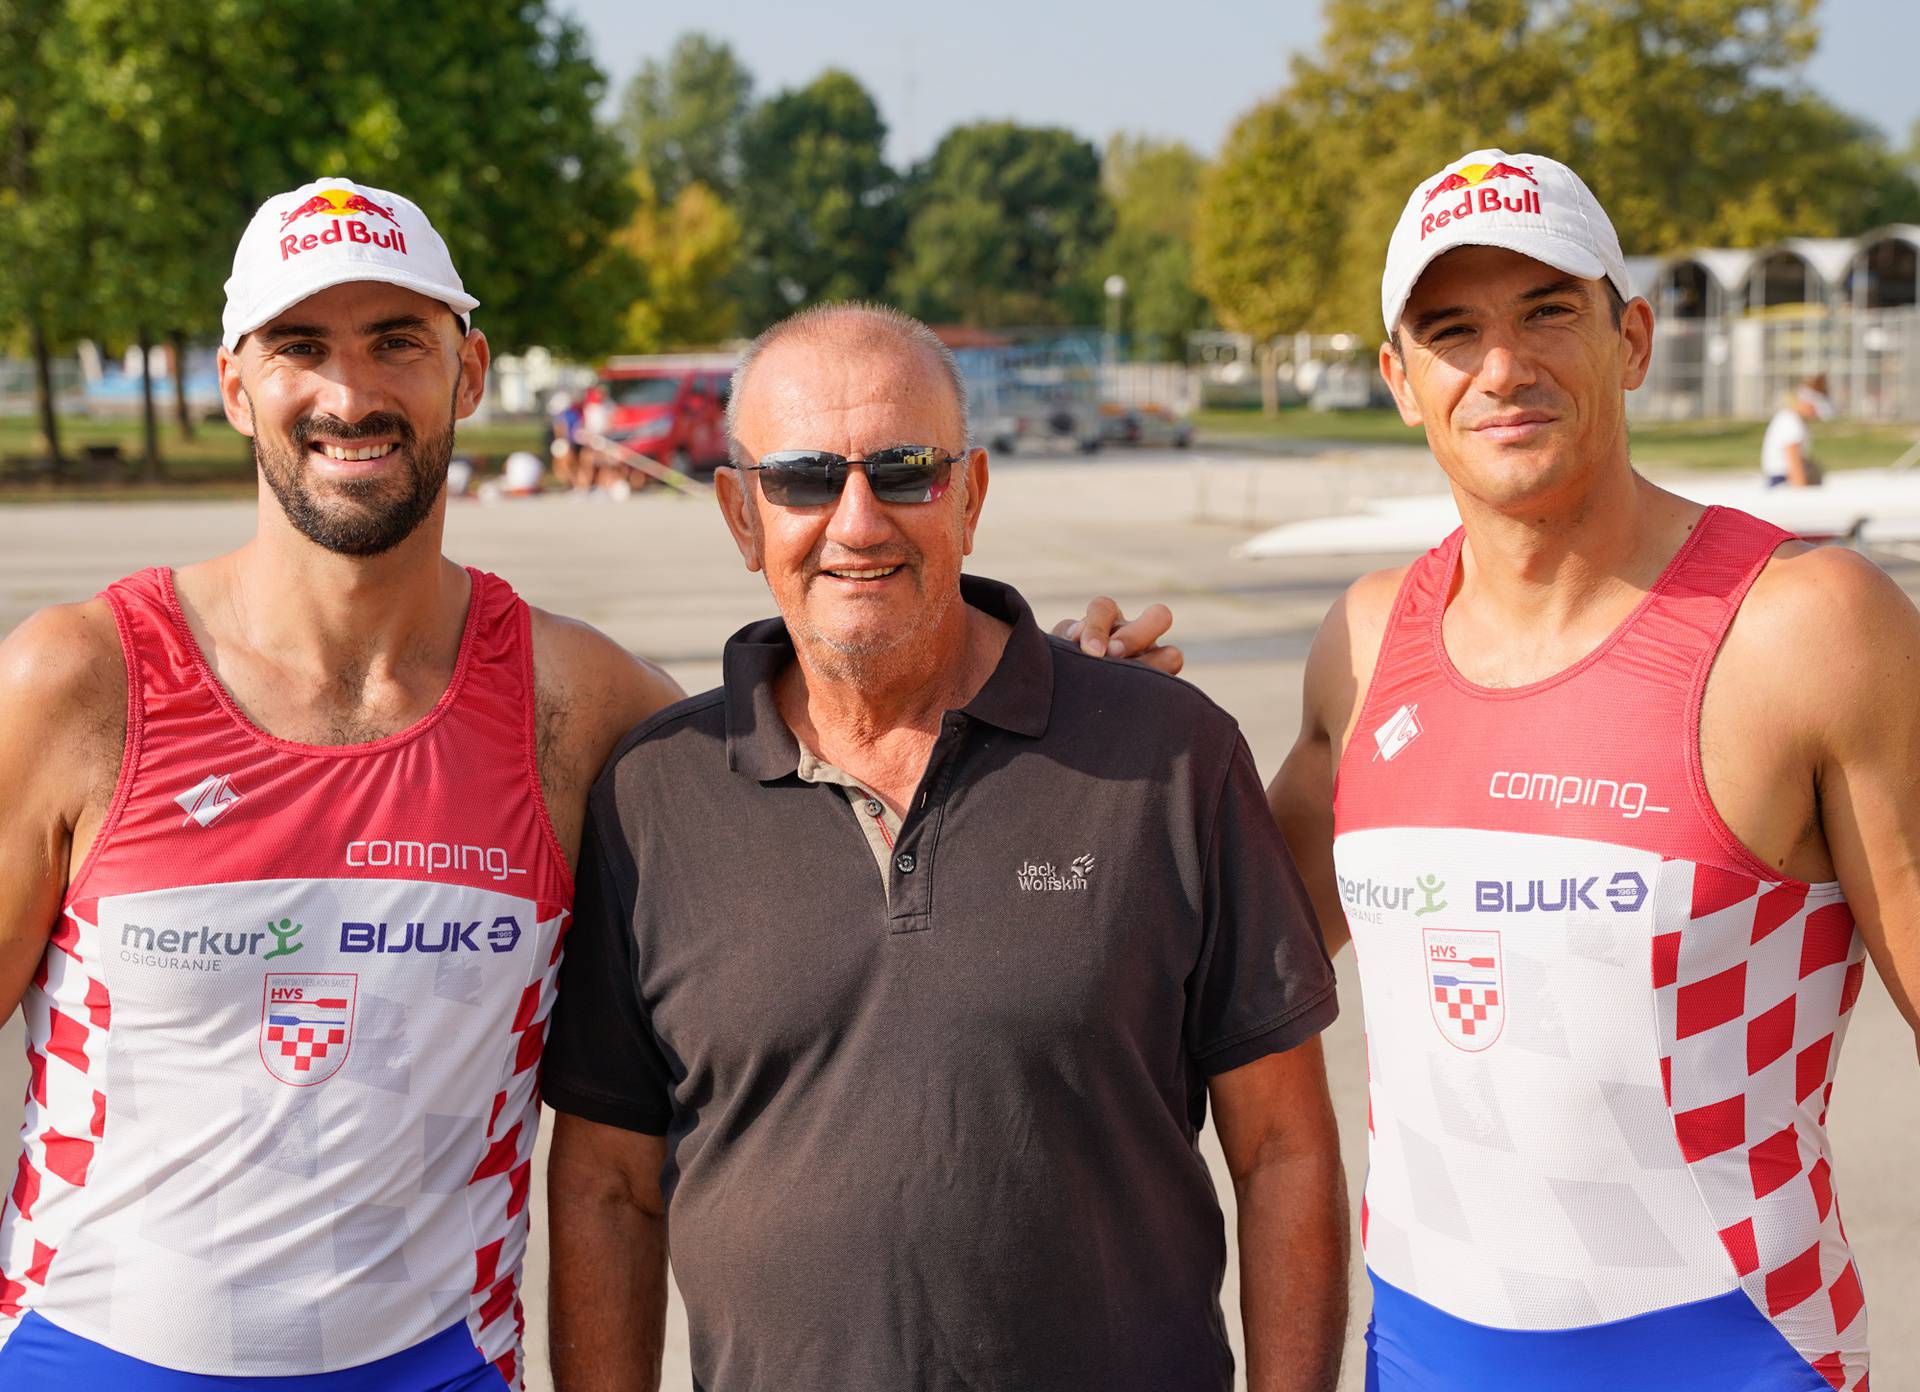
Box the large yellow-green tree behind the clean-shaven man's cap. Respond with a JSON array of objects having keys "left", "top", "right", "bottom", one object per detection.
[{"left": 1223, "top": 0, "right": 1920, "bottom": 330}]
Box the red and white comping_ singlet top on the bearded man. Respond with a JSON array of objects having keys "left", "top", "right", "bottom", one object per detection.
[{"left": 0, "top": 570, "right": 572, "bottom": 1388}]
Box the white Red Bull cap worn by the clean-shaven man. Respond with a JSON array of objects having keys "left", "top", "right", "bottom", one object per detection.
[{"left": 1380, "top": 150, "right": 1634, "bottom": 334}]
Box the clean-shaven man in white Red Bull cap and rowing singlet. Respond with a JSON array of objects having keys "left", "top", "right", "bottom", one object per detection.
[{"left": 1269, "top": 150, "right": 1920, "bottom": 1392}]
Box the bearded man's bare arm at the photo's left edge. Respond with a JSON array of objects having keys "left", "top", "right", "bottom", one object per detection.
[{"left": 0, "top": 601, "right": 127, "bottom": 1021}]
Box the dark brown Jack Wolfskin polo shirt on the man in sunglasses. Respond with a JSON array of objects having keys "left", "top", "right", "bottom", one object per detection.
[{"left": 543, "top": 578, "right": 1334, "bottom": 1392}]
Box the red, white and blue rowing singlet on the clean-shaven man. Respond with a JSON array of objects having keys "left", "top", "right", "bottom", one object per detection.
[{"left": 1334, "top": 509, "right": 1866, "bottom": 1392}]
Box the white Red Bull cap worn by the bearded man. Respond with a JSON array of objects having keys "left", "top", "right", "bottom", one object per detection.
[{"left": 221, "top": 179, "right": 480, "bottom": 351}]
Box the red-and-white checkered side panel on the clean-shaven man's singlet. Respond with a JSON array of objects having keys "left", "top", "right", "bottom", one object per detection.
[{"left": 1653, "top": 866, "right": 1866, "bottom": 1392}]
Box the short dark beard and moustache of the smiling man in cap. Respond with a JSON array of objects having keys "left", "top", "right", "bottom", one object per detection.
[{"left": 248, "top": 376, "right": 461, "bottom": 557}]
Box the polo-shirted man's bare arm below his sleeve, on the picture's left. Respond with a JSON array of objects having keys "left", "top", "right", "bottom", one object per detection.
[{"left": 547, "top": 1112, "right": 666, "bottom": 1392}]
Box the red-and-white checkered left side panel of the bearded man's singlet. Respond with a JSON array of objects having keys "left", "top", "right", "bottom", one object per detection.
[{"left": 0, "top": 908, "right": 113, "bottom": 1344}]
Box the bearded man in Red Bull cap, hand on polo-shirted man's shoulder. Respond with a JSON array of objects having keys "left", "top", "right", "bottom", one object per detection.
[{"left": 0, "top": 179, "right": 1179, "bottom": 1392}]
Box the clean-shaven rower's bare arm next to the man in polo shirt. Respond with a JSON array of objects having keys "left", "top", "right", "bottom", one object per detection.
[{"left": 1267, "top": 570, "right": 1405, "bottom": 956}]
